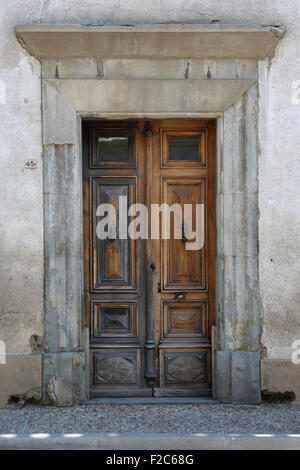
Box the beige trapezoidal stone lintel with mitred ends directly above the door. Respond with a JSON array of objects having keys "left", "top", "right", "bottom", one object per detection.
[{"left": 47, "top": 78, "right": 255, "bottom": 114}]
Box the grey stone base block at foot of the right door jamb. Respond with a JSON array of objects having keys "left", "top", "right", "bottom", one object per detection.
[{"left": 216, "top": 351, "right": 261, "bottom": 404}]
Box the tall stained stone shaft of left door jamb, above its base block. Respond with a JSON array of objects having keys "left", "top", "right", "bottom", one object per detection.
[{"left": 44, "top": 145, "right": 83, "bottom": 356}]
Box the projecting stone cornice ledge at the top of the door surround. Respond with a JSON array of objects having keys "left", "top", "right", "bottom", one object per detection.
[{"left": 16, "top": 24, "right": 285, "bottom": 59}]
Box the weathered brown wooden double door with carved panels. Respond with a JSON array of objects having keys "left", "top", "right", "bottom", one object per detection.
[{"left": 83, "top": 120, "right": 215, "bottom": 397}]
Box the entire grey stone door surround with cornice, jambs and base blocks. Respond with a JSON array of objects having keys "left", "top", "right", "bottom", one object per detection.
[{"left": 16, "top": 25, "right": 284, "bottom": 405}]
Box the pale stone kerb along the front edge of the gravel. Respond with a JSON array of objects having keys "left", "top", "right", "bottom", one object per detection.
[{"left": 0, "top": 433, "right": 300, "bottom": 451}]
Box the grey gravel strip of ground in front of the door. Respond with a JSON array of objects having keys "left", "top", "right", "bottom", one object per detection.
[{"left": 0, "top": 403, "right": 300, "bottom": 434}]
